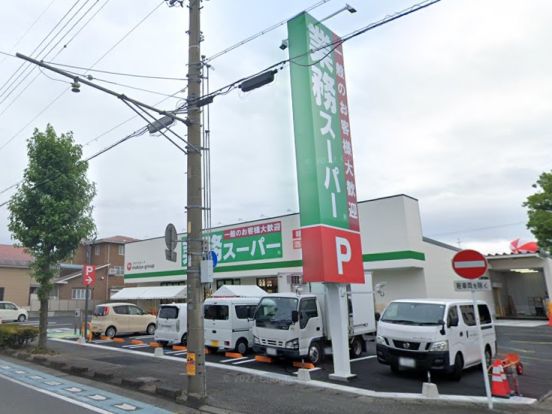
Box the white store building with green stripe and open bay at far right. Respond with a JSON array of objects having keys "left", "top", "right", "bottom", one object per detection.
[{"left": 125, "top": 194, "right": 552, "bottom": 317}]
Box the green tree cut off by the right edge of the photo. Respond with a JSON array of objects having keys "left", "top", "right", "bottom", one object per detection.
[{"left": 523, "top": 171, "right": 552, "bottom": 254}]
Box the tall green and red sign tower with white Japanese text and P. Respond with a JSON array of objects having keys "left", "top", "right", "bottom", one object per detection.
[{"left": 288, "top": 13, "right": 364, "bottom": 283}]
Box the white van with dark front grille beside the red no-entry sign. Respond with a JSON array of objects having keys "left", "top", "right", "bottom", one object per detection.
[{"left": 376, "top": 299, "right": 496, "bottom": 379}]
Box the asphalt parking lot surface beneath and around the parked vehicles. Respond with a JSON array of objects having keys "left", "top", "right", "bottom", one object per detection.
[{"left": 44, "top": 316, "right": 552, "bottom": 399}]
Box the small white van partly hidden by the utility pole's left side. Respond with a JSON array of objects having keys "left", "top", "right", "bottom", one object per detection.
[{"left": 153, "top": 303, "right": 188, "bottom": 346}]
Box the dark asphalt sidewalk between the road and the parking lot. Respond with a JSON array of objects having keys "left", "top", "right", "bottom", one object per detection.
[{"left": 4, "top": 341, "right": 552, "bottom": 414}]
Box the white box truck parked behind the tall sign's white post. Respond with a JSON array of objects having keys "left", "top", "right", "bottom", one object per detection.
[{"left": 252, "top": 274, "right": 376, "bottom": 364}]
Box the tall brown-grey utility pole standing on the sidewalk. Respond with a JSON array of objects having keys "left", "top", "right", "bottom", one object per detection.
[{"left": 186, "top": 0, "right": 207, "bottom": 401}]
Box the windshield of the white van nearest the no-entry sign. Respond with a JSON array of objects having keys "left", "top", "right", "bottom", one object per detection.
[{"left": 381, "top": 302, "right": 445, "bottom": 325}]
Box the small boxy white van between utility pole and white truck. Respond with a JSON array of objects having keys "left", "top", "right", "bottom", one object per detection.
[{"left": 203, "top": 297, "right": 260, "bottom": 354}]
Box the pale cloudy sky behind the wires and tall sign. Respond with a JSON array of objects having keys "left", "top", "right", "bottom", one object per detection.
[{"left": 0, "top": 0, "right": 552, "bottom": 253}]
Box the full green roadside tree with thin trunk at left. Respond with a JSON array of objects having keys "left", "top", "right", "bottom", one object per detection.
[{"left": 8, "top": 124, "right": 96, "bottom": 349}]
